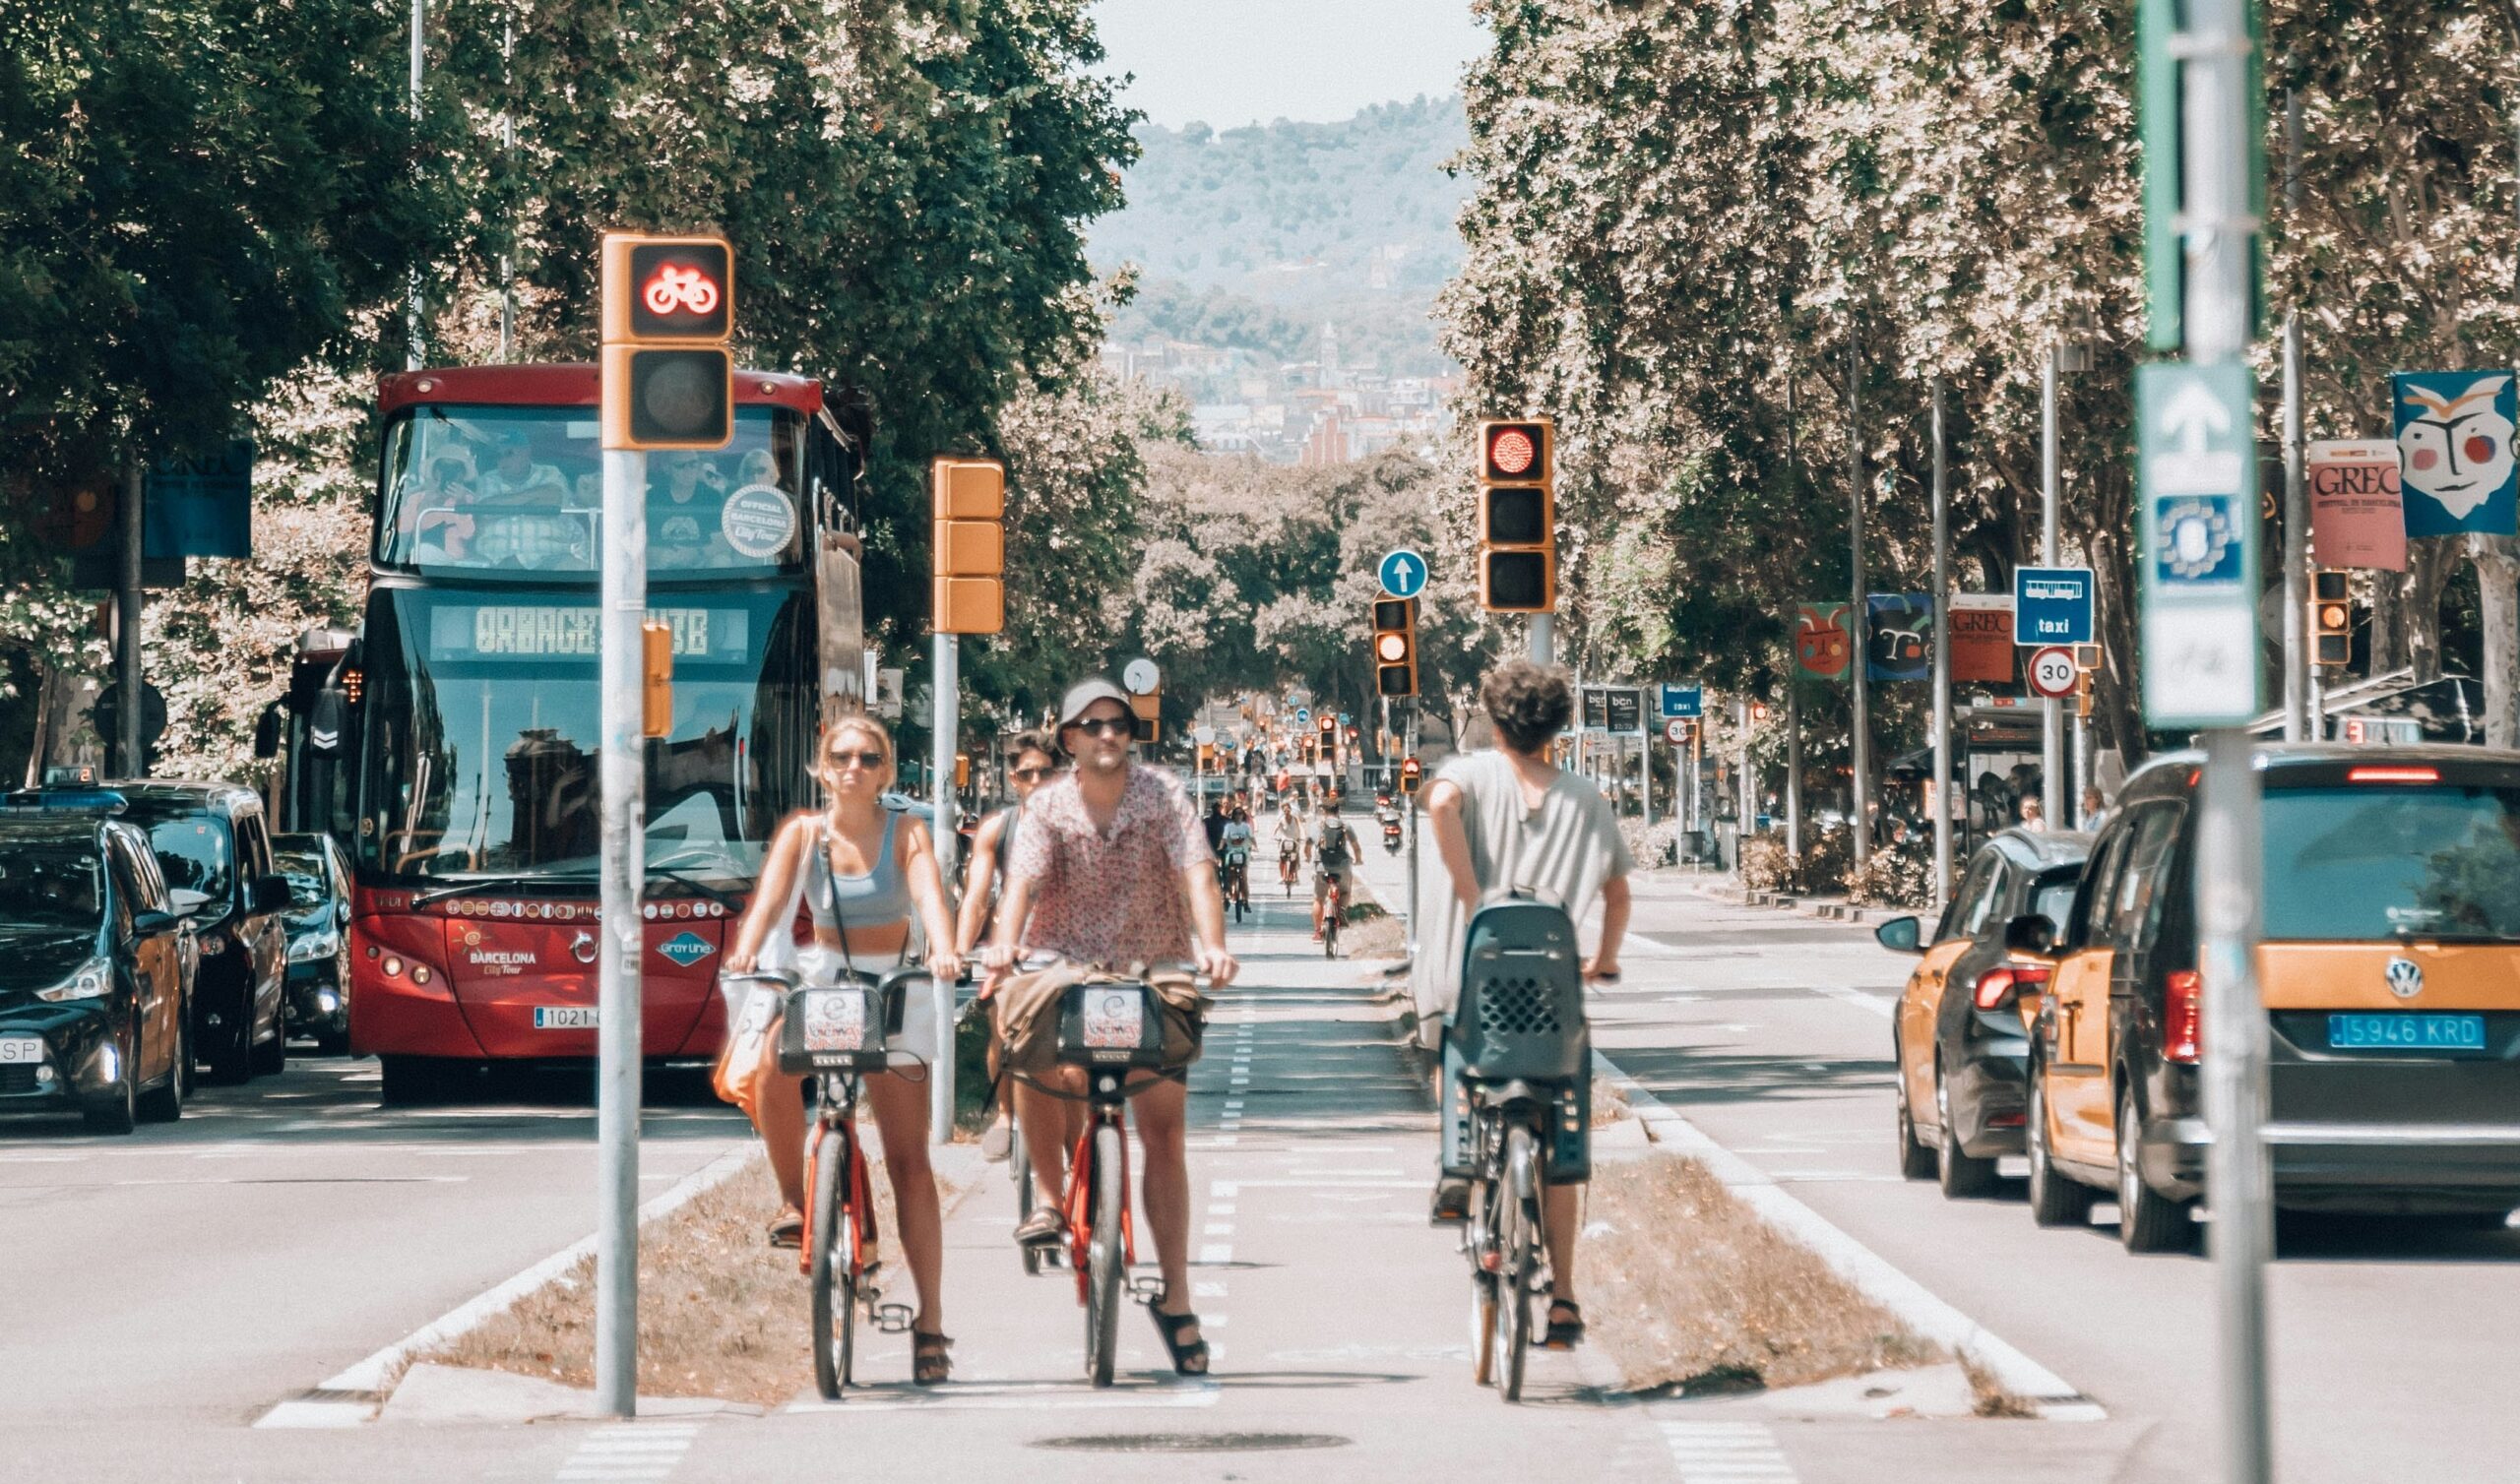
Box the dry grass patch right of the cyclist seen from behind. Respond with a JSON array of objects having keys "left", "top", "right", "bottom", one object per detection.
[{"left": 1578, "top": 1156, "right": 1943, "bottom": 1393}]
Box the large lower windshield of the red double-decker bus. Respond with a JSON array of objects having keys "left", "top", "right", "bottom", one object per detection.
[{"left": 355, "top": 589, "right": 814, "bottom": 890}]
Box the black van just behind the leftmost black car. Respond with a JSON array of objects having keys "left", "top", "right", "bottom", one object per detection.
[{"left": 108, "top": 778, "right": 289, "bottom": 1083}]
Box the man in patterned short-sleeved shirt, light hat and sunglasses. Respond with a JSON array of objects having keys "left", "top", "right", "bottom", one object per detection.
[{"left": 985, "top": 680, "right": 1234, "bottom": 1376}]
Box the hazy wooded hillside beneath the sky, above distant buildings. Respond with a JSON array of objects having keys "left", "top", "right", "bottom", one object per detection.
[{"left": 1089, "top": 95, "right": 1469, "bottom": 375}]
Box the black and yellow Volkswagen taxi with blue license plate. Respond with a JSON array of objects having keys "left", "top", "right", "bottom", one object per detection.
[{"left": 2013, "top": 743, "right": 2520, "bottom": 1252}]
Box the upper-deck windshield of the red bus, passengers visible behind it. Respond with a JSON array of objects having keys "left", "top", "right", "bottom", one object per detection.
[{"left": 375, "top": 405, "right": 804, "bottom": 580}]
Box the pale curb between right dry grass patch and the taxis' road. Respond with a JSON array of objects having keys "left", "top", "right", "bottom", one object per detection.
[{"left": 1593, "top": 1051, "right": 2110, "bottom": 1421}]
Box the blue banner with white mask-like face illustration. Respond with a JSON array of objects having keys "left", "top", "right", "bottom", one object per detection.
[{"left": 2389, "top": 370, "right": 2520, "bottom": 536}]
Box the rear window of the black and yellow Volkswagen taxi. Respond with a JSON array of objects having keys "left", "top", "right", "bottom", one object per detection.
[{"left": 2265, "top": 783, "right": 2520, "bottom": 940}]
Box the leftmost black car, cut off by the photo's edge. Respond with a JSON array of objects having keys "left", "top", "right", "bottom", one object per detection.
[{"left": 0, "top": 786, "right": 197, "bottom": 1134}]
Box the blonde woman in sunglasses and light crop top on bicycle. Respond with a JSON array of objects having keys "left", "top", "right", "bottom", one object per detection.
[{"left": 725, "top": 715, "right": 963, "bottom": 1386}]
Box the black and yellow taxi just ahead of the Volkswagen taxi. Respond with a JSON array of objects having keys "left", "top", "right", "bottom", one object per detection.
[{"left": 1872, "top": 829, "right": 2092, "bottom": 1197}]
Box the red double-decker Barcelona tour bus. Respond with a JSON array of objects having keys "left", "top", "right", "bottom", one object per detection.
[{"left": 289, "top": 365, "right": 864, "bottom": 1103}]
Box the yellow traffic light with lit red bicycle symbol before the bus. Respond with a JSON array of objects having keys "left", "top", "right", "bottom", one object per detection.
[{"left": 599, "top": 232, "right": 736, "bottom": 449}]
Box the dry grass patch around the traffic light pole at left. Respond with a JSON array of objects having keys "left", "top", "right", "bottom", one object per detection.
[{"left": 415, "top": 1154, "right": 912, "bottom": 1406}]
